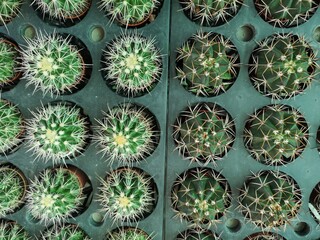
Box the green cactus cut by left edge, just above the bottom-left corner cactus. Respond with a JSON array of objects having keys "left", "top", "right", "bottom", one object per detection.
[{"left": 0, "top": 165, "right": 27, "bottom": 217}]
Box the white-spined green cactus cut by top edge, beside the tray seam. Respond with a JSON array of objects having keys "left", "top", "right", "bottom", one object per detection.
[{"left": 100, "top": 0, "right": 162, "bottom": 27}]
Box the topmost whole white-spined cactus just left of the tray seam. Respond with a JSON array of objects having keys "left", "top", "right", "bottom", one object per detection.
[{"left": 102, "top": 32, "right": 162, "bottom": 97}]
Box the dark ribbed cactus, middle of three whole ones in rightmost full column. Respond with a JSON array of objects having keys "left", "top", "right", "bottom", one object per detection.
[{"left": 244, "top": 105, "right": 309, "bottom": 165}]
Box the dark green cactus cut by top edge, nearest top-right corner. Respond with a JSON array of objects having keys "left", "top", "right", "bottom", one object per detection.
[{"left": 255, "top": 0, "right": 318, "bottom": 27}]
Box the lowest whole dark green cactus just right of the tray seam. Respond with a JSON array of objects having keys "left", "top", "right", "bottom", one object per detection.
[{"left": 172, "top": 168, "right": 231, "bottom": 226}]
